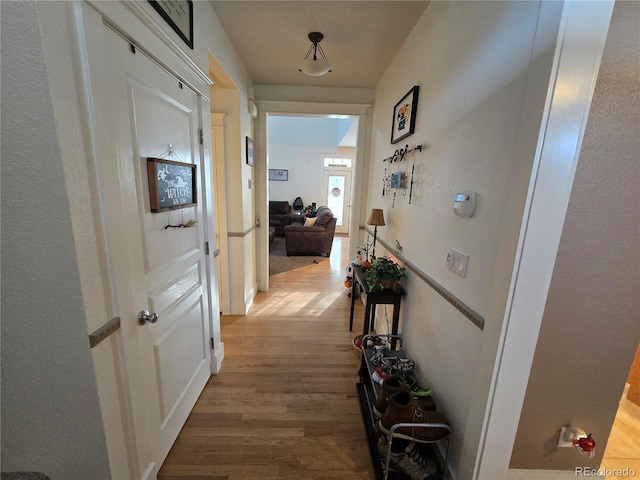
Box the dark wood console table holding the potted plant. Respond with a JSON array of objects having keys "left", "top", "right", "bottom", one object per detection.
[{"left": 349, "top": 264, "right": 405, "bottom": 349}]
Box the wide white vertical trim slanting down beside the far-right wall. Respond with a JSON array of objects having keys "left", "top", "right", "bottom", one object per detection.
[{"left": 473, "top": 0, "right": 614, "bottom": 480}]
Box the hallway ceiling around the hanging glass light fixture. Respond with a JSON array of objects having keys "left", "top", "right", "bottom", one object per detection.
[{"left": 210, "top": 0, "right": 429, "bottom": 88}]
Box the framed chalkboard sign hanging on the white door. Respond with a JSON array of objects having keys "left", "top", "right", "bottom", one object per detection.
[{"left": 147, "top": 158, "right": 198, "bottom": 213}]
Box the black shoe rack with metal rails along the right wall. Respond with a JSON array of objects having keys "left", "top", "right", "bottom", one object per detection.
[{"left": 356, "top": 335, "right": 451, "bottom": 480}]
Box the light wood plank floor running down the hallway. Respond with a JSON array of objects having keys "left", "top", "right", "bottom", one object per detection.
[{"left": 158, "top": 237, "right": 373, "bottom": 480}]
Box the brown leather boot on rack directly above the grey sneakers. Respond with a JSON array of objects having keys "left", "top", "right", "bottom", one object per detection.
[{"left": 380, "top": 390, "right": 449, "bottom": 442}]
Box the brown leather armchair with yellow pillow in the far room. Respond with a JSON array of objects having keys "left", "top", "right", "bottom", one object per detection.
[{"left": 284, "top": 207, "right": 337, "bottom": 257}]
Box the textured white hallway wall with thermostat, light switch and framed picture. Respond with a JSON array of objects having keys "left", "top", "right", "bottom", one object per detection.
[{"left": 367, "top": 2, "right": 559, "bottom": 478}]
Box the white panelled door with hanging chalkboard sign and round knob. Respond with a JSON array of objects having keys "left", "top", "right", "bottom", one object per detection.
[{"left": 103, "top": 30, "right": 211, "bottom": 478}]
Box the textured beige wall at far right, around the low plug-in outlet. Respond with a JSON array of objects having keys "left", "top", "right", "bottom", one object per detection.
[{"left": 511, "top": 2, "right": 640, "bottom": 470}]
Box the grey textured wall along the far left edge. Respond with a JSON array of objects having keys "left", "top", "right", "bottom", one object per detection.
[{"left": 2, "top": 2, "right": 110, "bottom": 480}]
